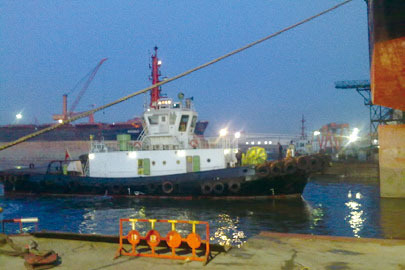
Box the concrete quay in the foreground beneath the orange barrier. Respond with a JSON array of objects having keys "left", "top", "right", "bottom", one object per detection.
[{"left": 0, "top": 232, "right": 405, "bottom": 270}]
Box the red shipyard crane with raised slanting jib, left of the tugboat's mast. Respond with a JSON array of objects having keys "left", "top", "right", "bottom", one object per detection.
[{"left": 53, "top": 58, "right": 108, "bottom": 123}]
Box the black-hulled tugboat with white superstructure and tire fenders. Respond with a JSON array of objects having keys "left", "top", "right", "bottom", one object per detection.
[{"left": 0, "top": 47, "right": 327, "bottom": 198}]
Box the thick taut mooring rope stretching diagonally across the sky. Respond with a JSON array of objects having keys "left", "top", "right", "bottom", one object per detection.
[{"left": 0, "top": 0, "right": 352, "bottom": 151}]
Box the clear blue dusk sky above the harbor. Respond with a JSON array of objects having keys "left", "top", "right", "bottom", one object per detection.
[{"left": 0, "top": 0, "right": 369, "bottom": 134}]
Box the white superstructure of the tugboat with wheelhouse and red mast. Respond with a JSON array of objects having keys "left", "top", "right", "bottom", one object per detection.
[{"left": 86, "top": 48, "right": 237, "bottom": 178}]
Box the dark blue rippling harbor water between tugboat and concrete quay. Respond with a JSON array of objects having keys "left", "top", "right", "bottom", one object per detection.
[{"left": 0, "top": 177, "right": 405, "bottom": 246}]
